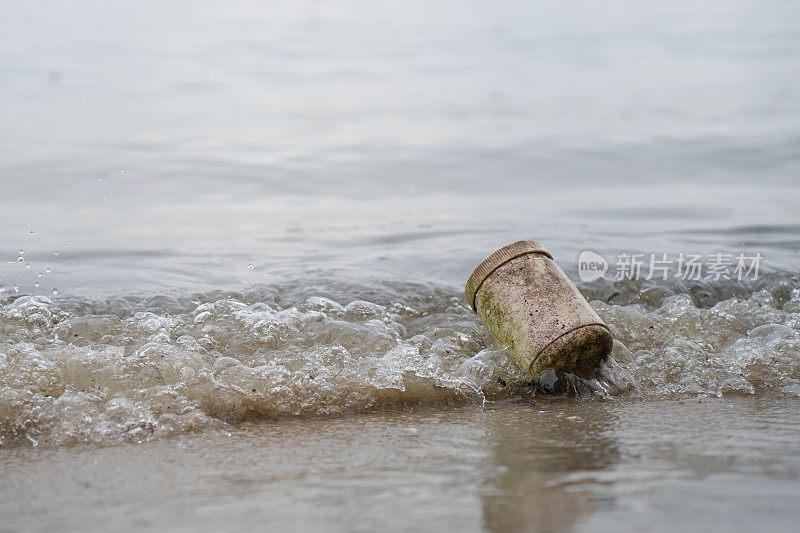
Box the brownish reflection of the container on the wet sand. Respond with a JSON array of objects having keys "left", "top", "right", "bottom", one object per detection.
[{"left": 481, "top": 400, "right": 619, "bottom": 531}]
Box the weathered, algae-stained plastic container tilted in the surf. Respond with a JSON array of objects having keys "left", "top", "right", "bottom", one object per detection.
[{"left": 465, "top": 241, "right": 612, "bottom": 379}]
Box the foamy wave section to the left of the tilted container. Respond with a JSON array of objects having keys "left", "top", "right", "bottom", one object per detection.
[{"left": 0, "top": 284, "right": 521, "bottom": 444}]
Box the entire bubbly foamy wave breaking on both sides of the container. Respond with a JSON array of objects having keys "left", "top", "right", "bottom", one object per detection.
[{"left": 0, "top": 278, "right": 800, "bottom": 445}]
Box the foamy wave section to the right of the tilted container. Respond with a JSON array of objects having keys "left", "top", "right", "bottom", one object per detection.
[{"left": 595, "top": 285, "right": 800, "bottom": 397}]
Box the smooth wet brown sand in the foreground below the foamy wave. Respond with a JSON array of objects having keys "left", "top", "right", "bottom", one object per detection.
[{"left": 0, "top": 397, "right": 800, "bottom": 532}]
